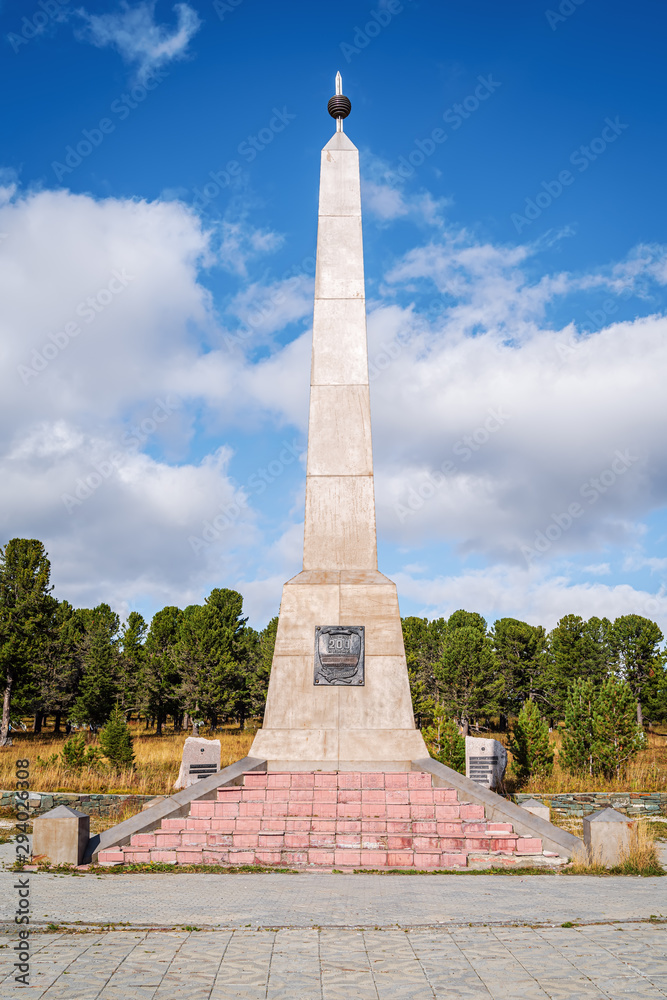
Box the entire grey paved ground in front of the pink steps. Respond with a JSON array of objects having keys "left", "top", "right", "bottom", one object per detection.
[{"left": 0, "top": 845, "right": 667, "bottom": 1000}]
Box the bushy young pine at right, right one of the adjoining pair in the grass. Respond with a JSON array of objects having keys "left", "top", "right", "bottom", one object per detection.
[{"left": 593, "top": 677, "right": 646, "bottom": 778}]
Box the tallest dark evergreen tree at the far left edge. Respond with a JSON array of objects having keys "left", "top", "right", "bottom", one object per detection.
[{"left": 0, "top": 538, "right": 57, "bottom": 746}]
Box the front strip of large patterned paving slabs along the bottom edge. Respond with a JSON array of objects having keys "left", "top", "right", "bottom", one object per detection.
[{"left": 0, "top": 924, "right": 667, "bottom": 1000}]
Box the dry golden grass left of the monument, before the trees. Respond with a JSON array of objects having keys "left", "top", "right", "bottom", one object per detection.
[{"left": 0, "top": 725, "right": 255, "bottom": 795}]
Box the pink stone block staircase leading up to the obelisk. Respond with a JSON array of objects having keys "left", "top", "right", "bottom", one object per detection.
[{"left": 99, "top": 771, "right": 561, "bottom": 869}]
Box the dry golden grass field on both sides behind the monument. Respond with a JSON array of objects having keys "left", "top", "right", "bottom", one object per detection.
[{"left": 0, "top": 723, "right": 667, "bottom": 795}]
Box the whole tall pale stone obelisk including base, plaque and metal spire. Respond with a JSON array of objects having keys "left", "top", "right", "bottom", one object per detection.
[{"left": 250, "top": 73, "right": 428, "bottom": 771}]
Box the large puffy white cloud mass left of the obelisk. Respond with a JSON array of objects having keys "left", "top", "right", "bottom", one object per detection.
[{"left": 0, "top": 184, "right": 257, "bottom": 609}]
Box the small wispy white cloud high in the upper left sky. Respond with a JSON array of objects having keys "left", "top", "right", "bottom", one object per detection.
[{"left": 76, "top": 0, "right": 201, "bottom": 82}]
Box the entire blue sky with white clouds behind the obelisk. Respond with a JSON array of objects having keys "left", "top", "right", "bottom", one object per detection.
[{"left": 0, "top": 0, "right": 667, "bottom": 629}]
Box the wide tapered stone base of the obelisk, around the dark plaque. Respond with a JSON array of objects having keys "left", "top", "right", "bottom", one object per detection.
[{"left": 250, "top": 570, "right": 429, "bottom": 771}]
